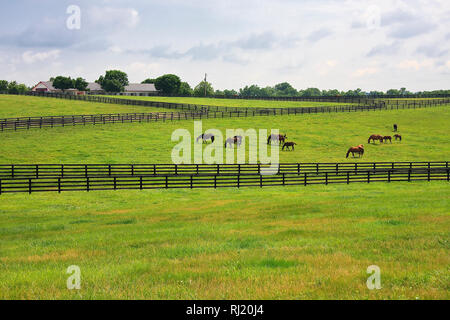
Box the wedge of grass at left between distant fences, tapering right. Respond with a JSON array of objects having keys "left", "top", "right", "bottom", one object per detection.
[{"left": 0, "top": 94, "right": 171, "bottom": 118}]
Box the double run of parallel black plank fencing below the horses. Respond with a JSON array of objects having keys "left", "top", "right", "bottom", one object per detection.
[{"left": 0, "top": 161, "right": 450, "bottom": 194}]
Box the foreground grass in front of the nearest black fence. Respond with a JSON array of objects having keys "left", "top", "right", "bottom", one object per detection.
[{"left": 0, "top": 182, "right": 450, "bottom": 299}]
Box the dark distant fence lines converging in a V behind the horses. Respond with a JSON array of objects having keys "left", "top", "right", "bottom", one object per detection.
[{"left": 0, "top": 92, "right": 450, "bottom": 131}]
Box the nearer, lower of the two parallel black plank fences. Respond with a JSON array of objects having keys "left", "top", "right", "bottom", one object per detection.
[{"left": 0, "top": 168, "right": 450, "bottom": 194}]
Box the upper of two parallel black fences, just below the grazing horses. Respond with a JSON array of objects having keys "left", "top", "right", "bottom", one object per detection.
[{"left": 0, "top": 161, "right": 449, "bottom": 179}]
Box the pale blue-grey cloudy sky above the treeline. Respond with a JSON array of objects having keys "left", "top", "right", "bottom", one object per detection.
[{"left": 0, "top": 0, "right": 450, "bottom": 91}]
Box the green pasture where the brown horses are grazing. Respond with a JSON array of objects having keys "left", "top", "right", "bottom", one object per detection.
[{"left": 0, "top": 107, "right": 450, "bottom": 163}]
